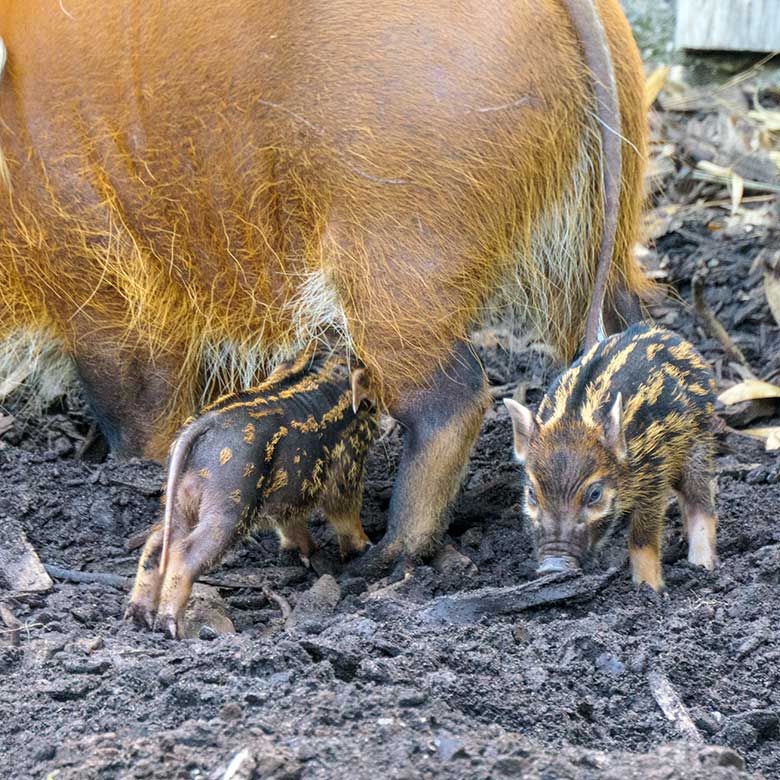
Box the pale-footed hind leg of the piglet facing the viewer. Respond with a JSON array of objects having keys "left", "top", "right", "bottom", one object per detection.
[{"left": 677, "top": 442, "right": 718, "bottom": 571}]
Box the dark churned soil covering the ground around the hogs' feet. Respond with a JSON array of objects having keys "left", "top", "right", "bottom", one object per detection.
[{"left": 0, "top": 214, "right": 780, "bottom": 780}]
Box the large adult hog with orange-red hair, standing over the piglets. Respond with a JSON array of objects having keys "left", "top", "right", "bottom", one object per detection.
[{"left": 0, "top": 0, "right": 647, "bottom": 571}]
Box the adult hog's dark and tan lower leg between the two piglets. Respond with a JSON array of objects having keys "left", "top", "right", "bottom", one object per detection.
[{"left": 349, "top": 343, "right": 489, "bottom": 577}]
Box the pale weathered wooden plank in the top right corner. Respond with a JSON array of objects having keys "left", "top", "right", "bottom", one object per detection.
[{"left": 675, "top": 0, "right": 780, "bottom": 52}]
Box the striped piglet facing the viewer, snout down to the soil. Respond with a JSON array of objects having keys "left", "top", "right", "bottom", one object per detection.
[{"left": 504, "top": 325, "right": 717, "bottom": 591}]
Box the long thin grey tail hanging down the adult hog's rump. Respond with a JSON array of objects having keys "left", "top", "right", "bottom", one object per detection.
[{"left": 563, "top": 0, "right": 623, "bottom": 351}]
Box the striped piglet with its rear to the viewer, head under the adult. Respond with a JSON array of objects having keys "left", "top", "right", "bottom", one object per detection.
[{"left": 126, "top": 354, "right": 376, "bottom": 637}]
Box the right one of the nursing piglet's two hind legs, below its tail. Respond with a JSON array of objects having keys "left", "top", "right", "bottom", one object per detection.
[{"left": 157, "top": 500, "right": 241, "bottom": 639}]
